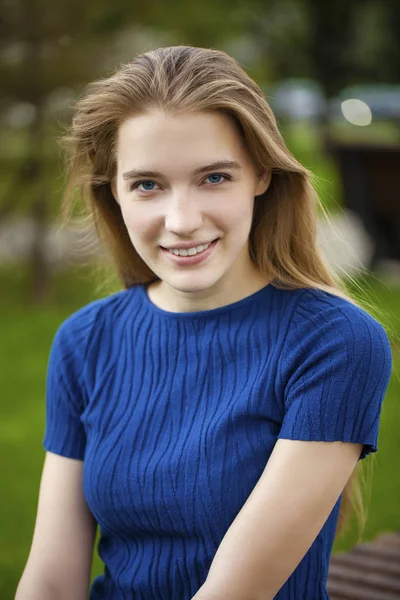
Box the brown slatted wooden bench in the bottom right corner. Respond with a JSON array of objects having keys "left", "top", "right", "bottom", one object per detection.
[{"left": 327, "top": 531, "right": 400, "bottom": 600}]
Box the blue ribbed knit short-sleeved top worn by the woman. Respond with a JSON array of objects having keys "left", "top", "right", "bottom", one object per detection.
[{"left": 44, "top": 284, "right": 392, "bottom": 600}]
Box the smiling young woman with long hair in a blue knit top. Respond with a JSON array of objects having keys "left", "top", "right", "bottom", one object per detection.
[{"left": 17, "top": 46, "right": 391, "bottom": 600}]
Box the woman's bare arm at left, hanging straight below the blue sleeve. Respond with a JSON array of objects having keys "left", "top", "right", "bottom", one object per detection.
[{"left": 15, "top": 452, "right": 96, "bottom": 600}]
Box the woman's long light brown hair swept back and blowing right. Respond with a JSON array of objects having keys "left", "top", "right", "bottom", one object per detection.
[{"left": 62, "top": 46, "right": 384, "bottom": 535}]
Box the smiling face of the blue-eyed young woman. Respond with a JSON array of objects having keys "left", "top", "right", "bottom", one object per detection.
[{"left": 113, "top": 111, "right": 270, "bottom": 303}]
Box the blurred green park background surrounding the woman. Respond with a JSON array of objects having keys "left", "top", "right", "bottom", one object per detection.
[{"left": 0, "top": 0, "right": 400, "bottom": 599}]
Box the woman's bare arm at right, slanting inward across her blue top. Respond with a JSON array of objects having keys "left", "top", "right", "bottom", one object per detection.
[{"left": 192, "top": 439, "right": 362, "bottom": 600}]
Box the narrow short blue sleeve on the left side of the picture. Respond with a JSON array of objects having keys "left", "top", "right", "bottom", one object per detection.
[{"left": 43, "top": 317, "right": 90, "bottom": 460}]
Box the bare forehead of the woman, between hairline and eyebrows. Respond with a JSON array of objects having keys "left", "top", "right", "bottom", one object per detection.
[{"left": 117, "top": 111, "right": 250, "bottom": 171}]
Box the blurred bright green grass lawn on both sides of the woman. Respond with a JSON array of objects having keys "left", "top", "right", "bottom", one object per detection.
[{"left": 0, "top": 268, "right": 400, "bottom": 599}]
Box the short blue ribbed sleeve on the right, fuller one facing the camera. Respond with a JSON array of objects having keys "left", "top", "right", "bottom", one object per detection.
[{"left": 278, "top": 291, "right": 392, "bottom": 460}]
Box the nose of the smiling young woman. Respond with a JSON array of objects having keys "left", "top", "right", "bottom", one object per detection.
[{"left": 165, "top": 194, "right": 203, "bottom": 237}]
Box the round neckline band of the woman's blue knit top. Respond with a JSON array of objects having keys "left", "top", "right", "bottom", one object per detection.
[{"left": 133, "top": 282, "right": 274, "bottom": 319}]
